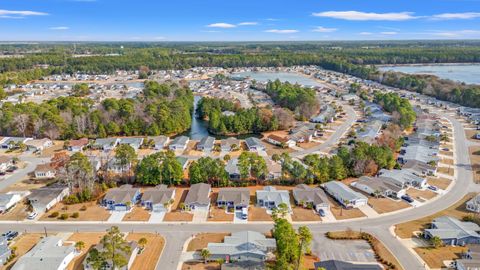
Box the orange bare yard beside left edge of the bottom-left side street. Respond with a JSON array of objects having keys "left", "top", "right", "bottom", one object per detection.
[{"left": 127, "top": 233, "right": 165, "bottom": 270}]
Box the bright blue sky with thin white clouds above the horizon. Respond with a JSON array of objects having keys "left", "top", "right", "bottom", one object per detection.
[{"left": 0, "top": 0, "right": 480, "bottom": 41}]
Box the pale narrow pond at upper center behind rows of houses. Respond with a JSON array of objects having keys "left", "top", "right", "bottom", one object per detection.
[{"left": 234, "top": 72, "right": 322, "bottom": 86}]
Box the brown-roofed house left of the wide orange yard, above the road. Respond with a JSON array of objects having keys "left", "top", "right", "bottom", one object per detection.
[{"left": 27, "top": 186, "right": 70, "bottom": 213}]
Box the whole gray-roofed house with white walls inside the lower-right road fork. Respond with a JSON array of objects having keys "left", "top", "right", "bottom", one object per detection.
[{"left": 424, "top": 216, "right": 480, "bottom": 246}]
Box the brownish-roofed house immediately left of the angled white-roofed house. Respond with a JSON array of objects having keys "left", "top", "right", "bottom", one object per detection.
[{"left": 292, "top": 184, "right": 330, "bottom": 212}]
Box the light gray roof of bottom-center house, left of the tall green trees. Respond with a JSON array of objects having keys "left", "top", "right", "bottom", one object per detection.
[{"left": 207, "top": 231, "right": 277, "bottom": 256}]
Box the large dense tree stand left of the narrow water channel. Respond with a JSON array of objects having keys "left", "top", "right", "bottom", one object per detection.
[{"left": 0, "top": 82, "right": 193, "bottom": 139}]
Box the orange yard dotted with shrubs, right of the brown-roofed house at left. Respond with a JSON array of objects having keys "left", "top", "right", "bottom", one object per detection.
[{"left": 40, "top": 202, "right": 110, "bottom": 221}]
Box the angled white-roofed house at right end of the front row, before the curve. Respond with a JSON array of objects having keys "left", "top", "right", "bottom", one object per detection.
[{"left": 323, "top": 181, "right": 368, "bottom": 208}]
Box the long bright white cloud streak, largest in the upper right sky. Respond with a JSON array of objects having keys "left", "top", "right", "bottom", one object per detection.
[{"left": 312, "top": 11, "right": 417, "bottom": 21}]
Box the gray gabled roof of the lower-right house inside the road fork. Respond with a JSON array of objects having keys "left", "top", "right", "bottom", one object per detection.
[{"left": 425, "top": 216, "right": 480, "bottom": 239}]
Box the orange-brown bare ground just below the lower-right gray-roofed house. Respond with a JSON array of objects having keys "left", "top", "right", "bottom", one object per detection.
[{"left": 414, "top": 246, "right": 468, "bottom": 269}]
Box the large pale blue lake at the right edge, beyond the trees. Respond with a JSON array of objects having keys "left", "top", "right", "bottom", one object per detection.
[{"left": 378, "top": 64, "right": 480, "bottom": 84}]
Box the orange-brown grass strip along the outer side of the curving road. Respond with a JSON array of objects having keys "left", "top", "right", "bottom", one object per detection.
[{"left": 395, "top": 193, "right": 475, "bottom": 238}]
